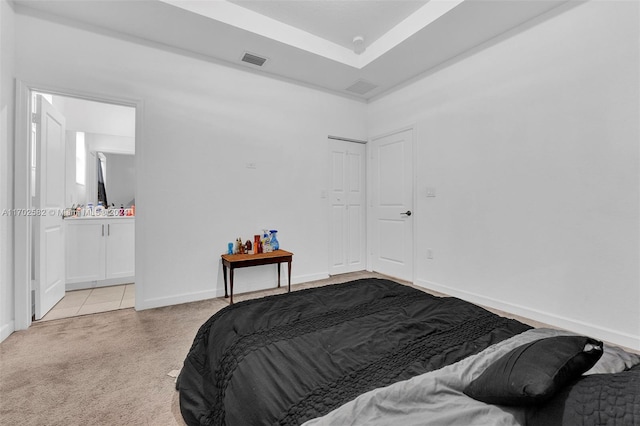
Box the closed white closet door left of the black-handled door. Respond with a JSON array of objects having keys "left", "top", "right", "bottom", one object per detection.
[{"left": 329, "top": 139, "right": 366, "bottom": 275}]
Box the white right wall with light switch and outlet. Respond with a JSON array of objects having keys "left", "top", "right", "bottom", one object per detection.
[{"left": 368, "top": 1, "right": 640, "bottom": 349}]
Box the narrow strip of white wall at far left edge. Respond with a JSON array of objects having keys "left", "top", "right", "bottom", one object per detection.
[{"left": 0, "top": 0, "right": 15, "bottom": 341}]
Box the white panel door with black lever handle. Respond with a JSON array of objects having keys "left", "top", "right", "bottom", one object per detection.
[{"left": 370, "top": 129, "right": 413, "bottom": 281}]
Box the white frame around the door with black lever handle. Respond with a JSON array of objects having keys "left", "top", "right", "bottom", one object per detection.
[{"left": 367, "top": 123, "right": 419, "bottom": 283}]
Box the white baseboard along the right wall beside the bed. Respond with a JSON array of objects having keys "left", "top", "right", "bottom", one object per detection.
[{"left": 415, "top": 280, "right": 640, "bottom": 351}]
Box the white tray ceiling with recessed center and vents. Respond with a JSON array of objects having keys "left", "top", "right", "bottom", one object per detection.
[{"left": 14, "top": 0, "right": 567, "bottom": 100}]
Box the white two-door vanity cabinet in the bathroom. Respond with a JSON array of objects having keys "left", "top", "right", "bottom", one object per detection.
[{"left": 65, "top": 218, "right": 135, "bottom": 289}]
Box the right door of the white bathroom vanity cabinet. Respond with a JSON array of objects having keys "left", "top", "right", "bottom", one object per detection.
[{"left": 106, "top": 219, "right": 136, "bottom": 279}]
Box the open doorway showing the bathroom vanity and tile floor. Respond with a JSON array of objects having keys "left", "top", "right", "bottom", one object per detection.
[{"left": 29, "top": 90, "right": 136, "bottom": 320}]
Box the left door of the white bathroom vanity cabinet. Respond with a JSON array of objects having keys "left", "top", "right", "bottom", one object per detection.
[{"left": 66, "top": 219, "right": 106, "bottom": 283}]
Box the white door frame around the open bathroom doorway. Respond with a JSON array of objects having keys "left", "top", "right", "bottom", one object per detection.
[{"left": 13, "top": 79, "right": 144, "bottom": 330}]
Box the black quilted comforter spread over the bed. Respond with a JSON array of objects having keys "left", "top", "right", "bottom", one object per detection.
[{"left": 178, "top": 279, "right": 530, "bottom": 426}]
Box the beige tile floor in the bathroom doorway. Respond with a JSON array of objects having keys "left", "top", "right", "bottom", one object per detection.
[{"left": 40, "top": 283, "right": 135, "bottom": 321}]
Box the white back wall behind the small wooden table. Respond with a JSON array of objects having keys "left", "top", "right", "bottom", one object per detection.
[{"left": 11, "top": 6, "right": 366, "bottom": 309}]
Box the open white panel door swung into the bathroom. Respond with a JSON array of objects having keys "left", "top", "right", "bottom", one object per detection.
[{"left": 34, "top": 95, "right": 66, "bottom": 320}]
